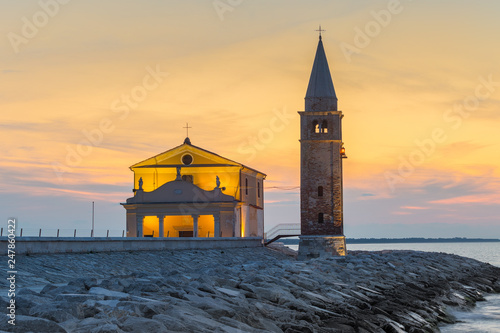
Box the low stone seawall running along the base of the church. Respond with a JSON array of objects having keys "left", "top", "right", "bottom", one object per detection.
[{"left": 0, "top": 237, "right": 262, "bottom": 254}]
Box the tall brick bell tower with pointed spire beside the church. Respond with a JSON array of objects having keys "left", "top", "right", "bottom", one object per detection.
[{"left": 298, "top": 27, "right": 346, "bottom": 259}]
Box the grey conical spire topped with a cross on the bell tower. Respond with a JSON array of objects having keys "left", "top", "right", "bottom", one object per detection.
[{"left": 305, "top": 26, "right": 338, "bottom": 111}]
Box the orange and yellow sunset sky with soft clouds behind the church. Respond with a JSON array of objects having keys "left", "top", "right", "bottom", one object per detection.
[{"left": 0, "top": 0, "right": 500, "bottom": 238}]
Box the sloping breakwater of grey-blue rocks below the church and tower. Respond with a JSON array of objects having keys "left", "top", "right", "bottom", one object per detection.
[{"left": 0, "top": 248, "right": 500, "bottom": 333}]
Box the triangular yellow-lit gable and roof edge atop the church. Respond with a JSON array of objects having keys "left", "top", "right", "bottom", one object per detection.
[{"left": 130, "top": 138, "right": 266, "bottom": 177}]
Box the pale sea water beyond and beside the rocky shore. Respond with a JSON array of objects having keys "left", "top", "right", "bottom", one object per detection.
[{"left": 288, "top": 242, "right": 500, "bottom": 333}]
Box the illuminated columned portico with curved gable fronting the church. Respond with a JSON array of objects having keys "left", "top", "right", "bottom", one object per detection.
[{"left": 122, "top": 180, "right": 237, "bottom": 237}]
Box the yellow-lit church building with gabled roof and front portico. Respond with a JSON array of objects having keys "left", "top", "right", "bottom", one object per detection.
[{"left": 122, "top": 137, "right": 266, "bottom": 237}]
